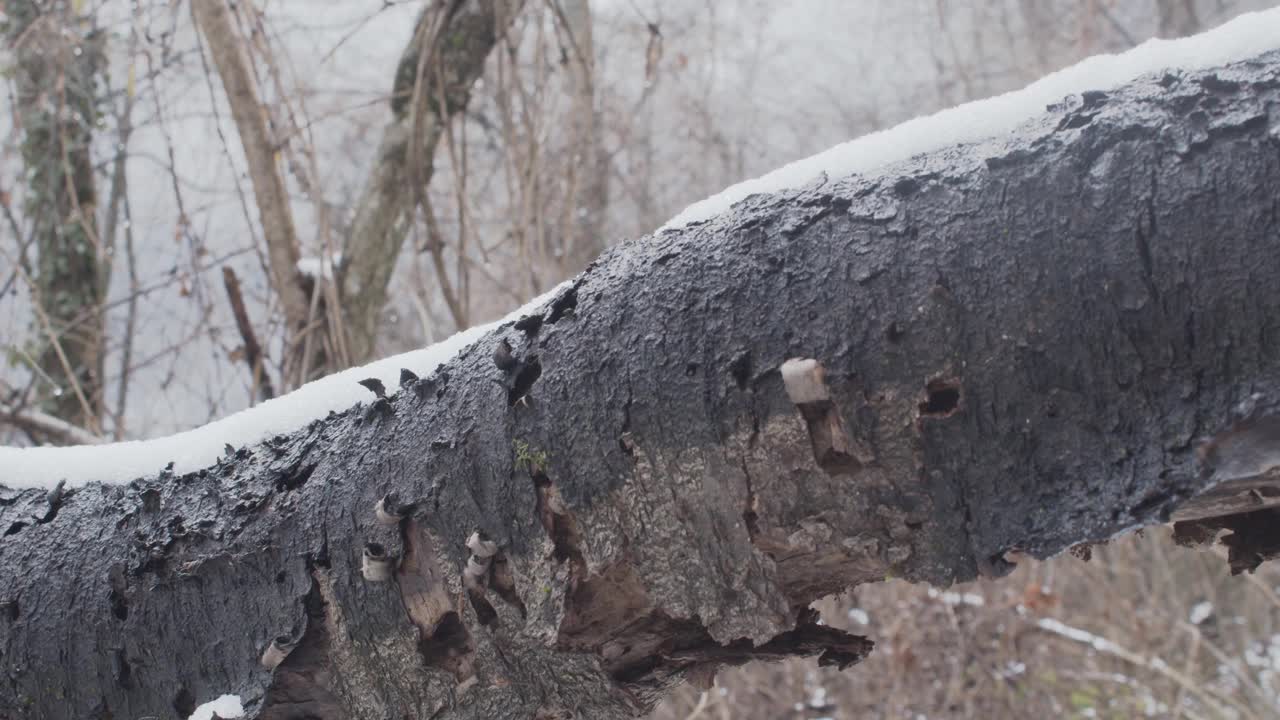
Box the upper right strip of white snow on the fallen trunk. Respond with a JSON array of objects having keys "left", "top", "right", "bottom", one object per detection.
[{"left": 660, "top": 8, "right": 1280, "bottom": 231}]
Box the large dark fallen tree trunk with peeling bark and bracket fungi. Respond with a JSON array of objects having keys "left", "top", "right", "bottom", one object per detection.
[{"left": 0, "top": 54, "right": 1280, "bottom": 719}]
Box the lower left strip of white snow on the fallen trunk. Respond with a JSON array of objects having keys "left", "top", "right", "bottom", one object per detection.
[{"left": 0, "top": 281, "right": 572, "bottom": 488}]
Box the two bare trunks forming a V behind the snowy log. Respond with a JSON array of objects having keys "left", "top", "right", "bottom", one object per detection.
[{"left": 192, "top": 0, "right": 521, "bottom": 387}]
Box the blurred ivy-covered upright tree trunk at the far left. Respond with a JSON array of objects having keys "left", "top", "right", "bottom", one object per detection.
[{"left": 4, "top": 0, "right": 110, "bottom": 427}]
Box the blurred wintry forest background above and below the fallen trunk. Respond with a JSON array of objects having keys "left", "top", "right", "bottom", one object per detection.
[{"left": 0, "top": 0, "right": 1280, "bottom": 720}]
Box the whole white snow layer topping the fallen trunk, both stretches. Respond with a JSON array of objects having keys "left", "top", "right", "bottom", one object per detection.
[{"left": 0, "top": 9, "right": 1280, "bottom": 487}]
